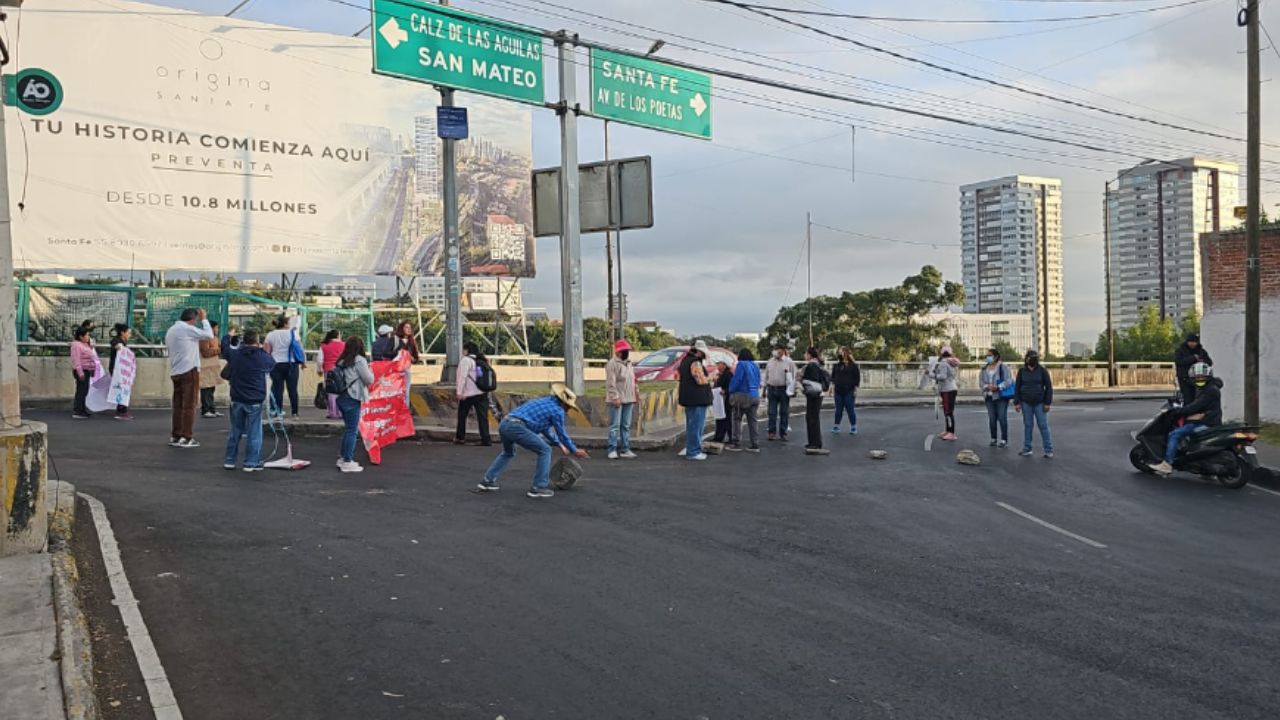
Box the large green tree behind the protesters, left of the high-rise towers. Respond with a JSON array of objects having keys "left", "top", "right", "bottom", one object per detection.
[{"left": 758, "top": 265, "right": 964, "bottom": 361}]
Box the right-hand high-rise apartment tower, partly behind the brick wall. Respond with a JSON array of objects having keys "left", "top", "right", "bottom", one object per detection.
[{"left": 1106, "top": 158, "right": 1239, "bottom": 328}]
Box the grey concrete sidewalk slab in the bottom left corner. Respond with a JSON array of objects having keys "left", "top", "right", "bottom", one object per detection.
[{"left": 0, "top": 552, "right": 65, "bottom": 720}]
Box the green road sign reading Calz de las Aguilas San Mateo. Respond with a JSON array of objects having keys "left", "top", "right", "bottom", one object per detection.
[{"left": 371, "top": 0, "right": 544, "bottom": 105}]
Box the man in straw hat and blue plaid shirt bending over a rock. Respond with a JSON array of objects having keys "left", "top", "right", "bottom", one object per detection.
[{"left": 479, "top": 383, "right": 588, "bottom": 500}]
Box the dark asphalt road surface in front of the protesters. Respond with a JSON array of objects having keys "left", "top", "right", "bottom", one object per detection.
[{"left": 36, "top": 402, "right": 1280, "bottom": 720}]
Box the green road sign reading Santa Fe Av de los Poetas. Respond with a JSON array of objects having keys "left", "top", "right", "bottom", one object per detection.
[{"left": 591, "top": 49, "right": 712, "bottom": 140}]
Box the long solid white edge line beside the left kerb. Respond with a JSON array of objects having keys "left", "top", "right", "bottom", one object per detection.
[{"left": 78, "top": 492, "right": 182, "bottom": 720}]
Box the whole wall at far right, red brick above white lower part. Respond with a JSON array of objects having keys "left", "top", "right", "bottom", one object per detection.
[{"left": 1201, "top": 228, "right": 1280, "bottom": 423}]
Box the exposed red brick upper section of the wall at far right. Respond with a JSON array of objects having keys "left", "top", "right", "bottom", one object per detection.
[{"left": 1201, "top": 228, "right": 1280, "bottom": 313}]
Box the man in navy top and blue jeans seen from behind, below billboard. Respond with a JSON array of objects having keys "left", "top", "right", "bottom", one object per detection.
[{"left": 223, "top": 331, "right": 275, "bottom": 473}]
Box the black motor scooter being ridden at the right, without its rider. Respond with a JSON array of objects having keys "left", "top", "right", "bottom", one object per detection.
[{"left": 1129, "top": 397, "right": 1258, "bottom": 489}]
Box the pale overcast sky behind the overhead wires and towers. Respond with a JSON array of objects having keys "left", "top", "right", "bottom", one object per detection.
[{"left": 145, "top": 0, "right": 1280, "bottom": 343}]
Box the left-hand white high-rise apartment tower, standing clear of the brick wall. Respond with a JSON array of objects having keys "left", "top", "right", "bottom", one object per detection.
[{"left": 960, "top": 176, "right": 1066, "bottom": 355}]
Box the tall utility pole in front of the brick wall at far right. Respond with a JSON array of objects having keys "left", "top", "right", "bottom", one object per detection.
[{"left": 1244, "top": 0, "right": 1262, "bottom": 425}]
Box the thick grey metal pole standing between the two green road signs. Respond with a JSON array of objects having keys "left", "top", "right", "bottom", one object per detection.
[{"left": 556, "top": 31, "right": 585, "bottom": 395}]
